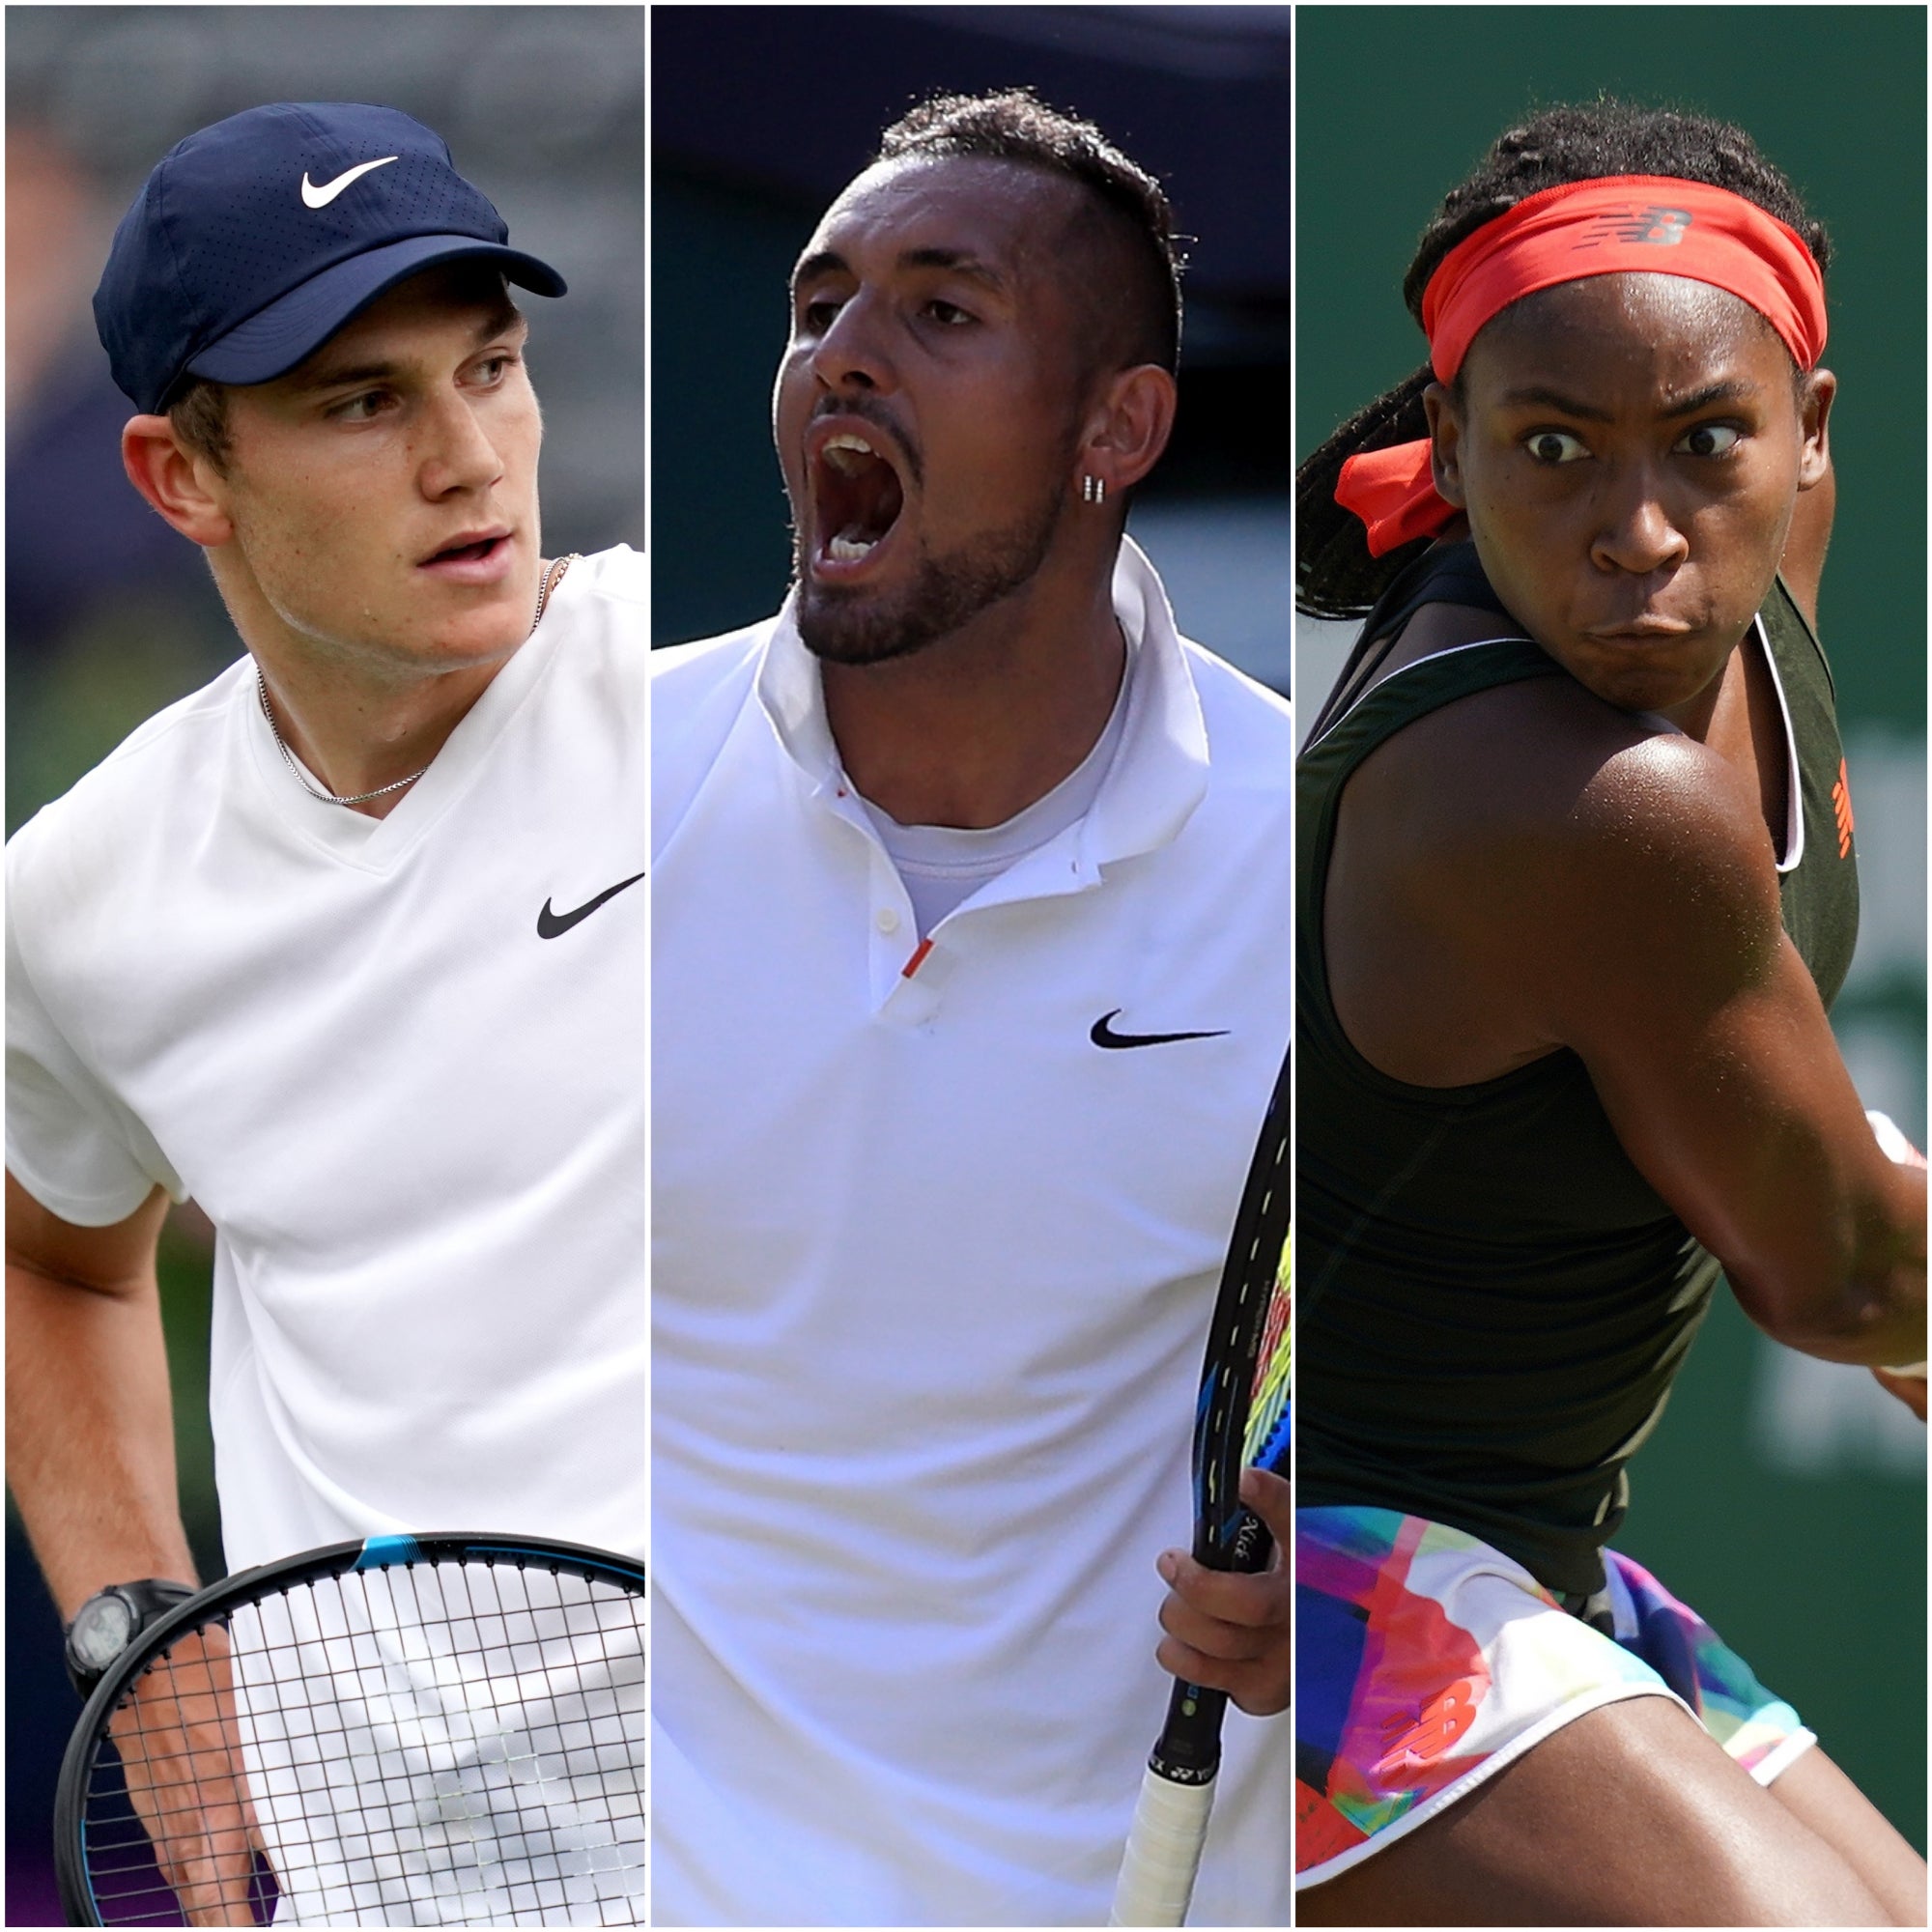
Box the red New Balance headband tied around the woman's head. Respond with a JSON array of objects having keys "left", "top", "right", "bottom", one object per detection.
[{"left": 1335, "top": 174, "right": 1824, "bottom": 556}]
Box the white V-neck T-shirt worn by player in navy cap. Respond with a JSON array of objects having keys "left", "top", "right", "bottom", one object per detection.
[{"left": 8, "top": 549, "right": 649, "bottom": 1569}]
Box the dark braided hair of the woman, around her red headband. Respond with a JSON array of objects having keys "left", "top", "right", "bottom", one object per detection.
[{"left": 1294, "top": 100, "right": 1832, "bottom": 616}]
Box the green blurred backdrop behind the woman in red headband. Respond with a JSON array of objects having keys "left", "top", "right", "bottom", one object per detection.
[{"left": 1294, "top": 6, "right": 1926, "bottom": 1851}]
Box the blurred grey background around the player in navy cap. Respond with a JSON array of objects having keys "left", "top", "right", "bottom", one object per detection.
[{"left": 6, "top": 6, "right": 645, "bottom": 1926}]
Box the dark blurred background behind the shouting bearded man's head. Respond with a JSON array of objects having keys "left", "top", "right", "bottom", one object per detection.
[{"left": 651, "top": 6, "right": 1291, "bottom": 684}]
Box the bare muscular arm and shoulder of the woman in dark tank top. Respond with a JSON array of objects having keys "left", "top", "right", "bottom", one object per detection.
[{"left": 1476, "top": 738, "right": 1926, "bottom": 1364}]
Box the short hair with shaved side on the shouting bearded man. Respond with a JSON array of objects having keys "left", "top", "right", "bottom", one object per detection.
[{"left": 877, "top": 87, "right": 1186, "bottom": 371}]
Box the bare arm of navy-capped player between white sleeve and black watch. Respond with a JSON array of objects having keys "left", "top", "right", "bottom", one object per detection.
[{"left": 6, "top": 1175, "right": 195, "bottom": 1619}]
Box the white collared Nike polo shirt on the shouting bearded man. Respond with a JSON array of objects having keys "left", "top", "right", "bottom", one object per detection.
[{"left": 651, "top": 545, "right": 1294, "bottom": 1924}]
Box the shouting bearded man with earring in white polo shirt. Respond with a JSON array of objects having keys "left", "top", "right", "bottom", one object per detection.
[{"left": 653, "top": 93, "right": 1293, "bottom": 1924}]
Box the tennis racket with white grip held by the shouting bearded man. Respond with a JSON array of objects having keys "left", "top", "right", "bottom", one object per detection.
[{"left": 1109, "top": 1057, "right": 1293, "bottom": 1926}]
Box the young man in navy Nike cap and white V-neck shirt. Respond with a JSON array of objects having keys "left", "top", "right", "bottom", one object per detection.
[{"left": 8, "top": 102, "right": 647, "bottom": 1924}]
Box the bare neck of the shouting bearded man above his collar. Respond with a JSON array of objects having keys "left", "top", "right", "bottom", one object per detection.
[{"left": 823, "top": 560, "right": 1126, "bottom": 829}]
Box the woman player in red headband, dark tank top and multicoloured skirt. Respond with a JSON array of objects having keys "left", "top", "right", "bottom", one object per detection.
[{"left": 1294, "top": 104, "right": 1926, "bottom": 1926}]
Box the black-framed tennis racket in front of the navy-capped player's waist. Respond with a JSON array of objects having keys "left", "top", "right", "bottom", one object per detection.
[{"left": 54, "top": 1536, "right": 645, "bottom": 1926}]
